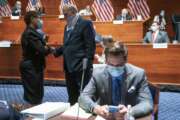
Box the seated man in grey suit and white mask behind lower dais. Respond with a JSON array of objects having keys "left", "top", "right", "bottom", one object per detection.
[{"left": 143, "top": 22, "right": 169, "bottom": 43}]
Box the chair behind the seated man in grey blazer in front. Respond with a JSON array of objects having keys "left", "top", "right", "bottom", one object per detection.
[{"left": 148, "top": 82, "right": 160, "bottom": 120}]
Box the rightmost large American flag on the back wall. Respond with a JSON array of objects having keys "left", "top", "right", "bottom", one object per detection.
[{"left": 127, "top": 0, "right": 150, "bottom": 20}]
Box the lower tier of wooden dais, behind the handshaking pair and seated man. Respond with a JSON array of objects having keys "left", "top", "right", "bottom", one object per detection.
[{"left": 0, "top": 44, "right": 180, "bottom": 85}]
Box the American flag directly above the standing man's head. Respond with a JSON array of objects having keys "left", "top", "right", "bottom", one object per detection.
[{"left": 59, "top": 0, "right": 77, "bottom": 15}]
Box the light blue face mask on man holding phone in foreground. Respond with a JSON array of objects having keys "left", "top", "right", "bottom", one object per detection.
[{"left": 107, "top": 65, "right": 125, "bottom": 77}]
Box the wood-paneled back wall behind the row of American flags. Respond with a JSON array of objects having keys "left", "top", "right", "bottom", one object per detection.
[{"left": 8, "top": 0, "right": 180, "bottom": 37}]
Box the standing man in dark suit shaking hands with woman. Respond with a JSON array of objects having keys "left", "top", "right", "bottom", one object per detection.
[{"left": 54, "top": 5, "right": 95, "bottom": 105}]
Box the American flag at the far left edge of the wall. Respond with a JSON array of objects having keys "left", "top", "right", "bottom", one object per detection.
[{"left": 0, "top": 0, "right": 12, "bottom": 16}]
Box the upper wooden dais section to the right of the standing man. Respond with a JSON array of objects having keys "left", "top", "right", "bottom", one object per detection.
[{"left": 94, "top": 21, "right": 148, "bottom": 43}]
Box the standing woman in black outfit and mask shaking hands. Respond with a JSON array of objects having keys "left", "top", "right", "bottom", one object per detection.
[{"left": 20, "top": 11, "right": 50, "bottom": 105}]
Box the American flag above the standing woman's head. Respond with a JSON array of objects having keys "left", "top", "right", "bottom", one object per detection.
[{"left": 26, "top": 0, "right": 42, "bottom": 11}]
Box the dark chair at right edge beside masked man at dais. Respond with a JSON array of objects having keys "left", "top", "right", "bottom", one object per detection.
[{"left": 172, "top": 14, "right": 180, "bottom": 42}]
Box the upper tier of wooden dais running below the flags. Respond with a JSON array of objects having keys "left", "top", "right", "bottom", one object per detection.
[{"left": 0, "top": 16, "right": 148, "bottom": 44}]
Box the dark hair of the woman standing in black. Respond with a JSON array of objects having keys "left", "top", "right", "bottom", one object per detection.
[{"left": 24, "top": 11, "right": 38, "bottom": 26}]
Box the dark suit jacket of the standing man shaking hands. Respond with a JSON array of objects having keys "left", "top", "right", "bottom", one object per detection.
[{"left": 56, "top": 17, "right": 95, "bottom": 73}]
